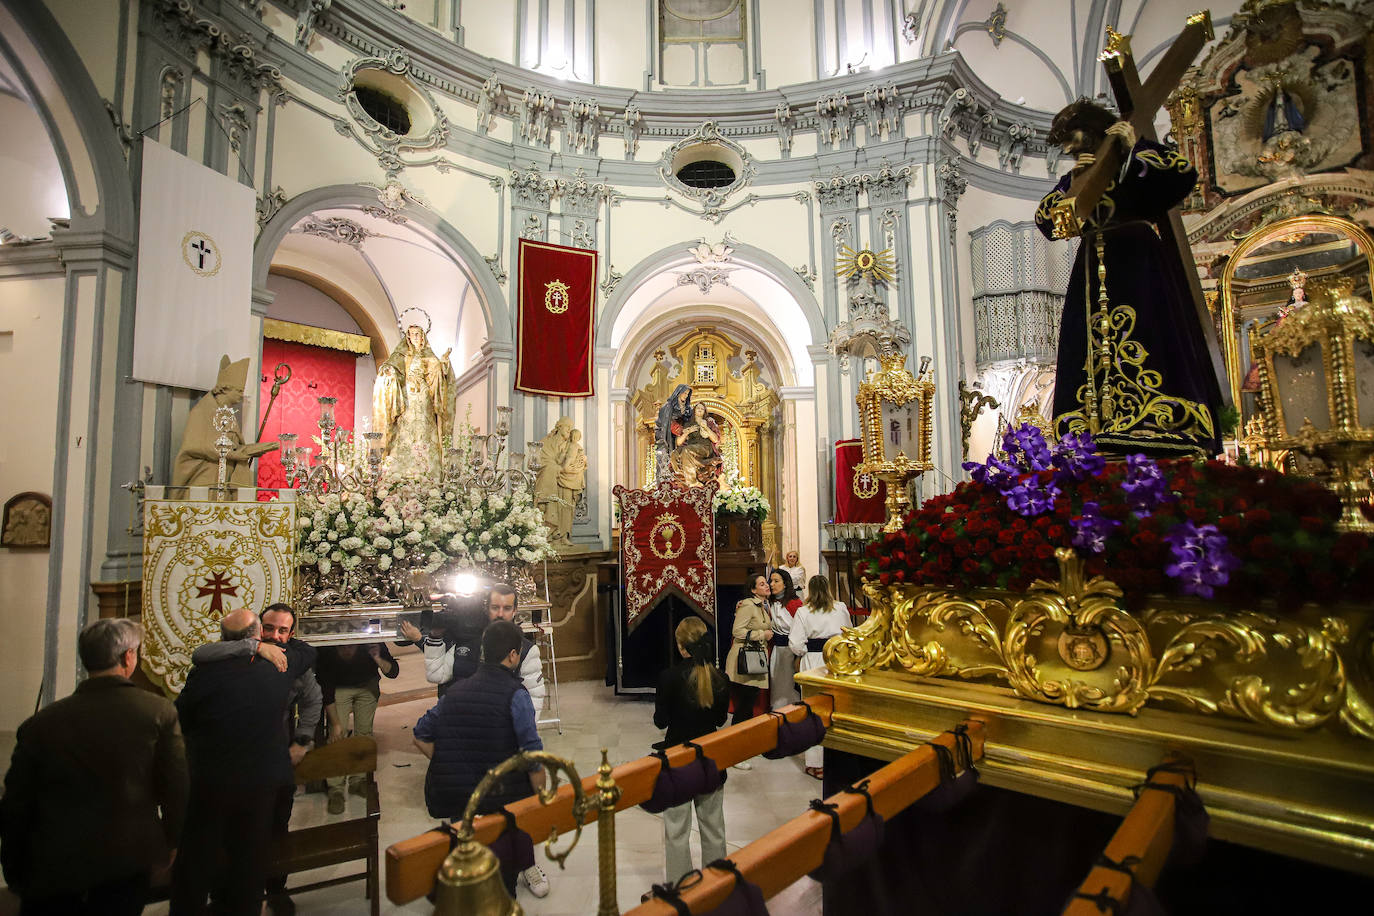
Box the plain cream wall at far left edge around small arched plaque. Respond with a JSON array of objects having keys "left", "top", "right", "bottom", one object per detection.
[{"left": 0, "top": 276, "right": 65, "bottom": 732}]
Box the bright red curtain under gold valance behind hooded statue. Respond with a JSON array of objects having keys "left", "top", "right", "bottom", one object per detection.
[{"left": 257, "top": 339, "right": 357, "bottom": 488}]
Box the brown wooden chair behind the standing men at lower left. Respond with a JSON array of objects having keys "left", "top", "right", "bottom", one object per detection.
[{"left": 268, "top": 735, "right": 382, "bottom": 916}]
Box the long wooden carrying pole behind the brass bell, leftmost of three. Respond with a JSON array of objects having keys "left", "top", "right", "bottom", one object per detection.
[{"left": 386, "top": 695, "right": 834, "bottom": 904}]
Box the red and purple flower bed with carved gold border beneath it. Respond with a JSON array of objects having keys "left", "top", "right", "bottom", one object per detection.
[{"left": 826, "top": 426, "right": 1374, "bottom": 739}]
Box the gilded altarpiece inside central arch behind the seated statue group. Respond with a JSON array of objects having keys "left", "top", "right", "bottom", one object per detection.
[{"left": 628, "top": 327, "right": 782, "bottom": 555}]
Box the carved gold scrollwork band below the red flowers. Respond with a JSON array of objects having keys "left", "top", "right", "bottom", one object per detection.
[{"left": 826, "top": 548, "right": 1374, "bottom": 739}]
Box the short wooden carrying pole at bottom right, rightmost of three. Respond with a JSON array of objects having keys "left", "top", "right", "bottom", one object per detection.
[{"left": 1063, "top": 758, "right": 1189, "bottom": 916}]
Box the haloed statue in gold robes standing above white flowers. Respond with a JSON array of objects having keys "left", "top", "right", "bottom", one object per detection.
[{"left": 372, "top": 324, "right": 458, "bottom": 483}]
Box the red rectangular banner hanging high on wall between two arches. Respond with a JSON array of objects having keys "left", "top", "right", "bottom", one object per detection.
[{"left": 515, "top": 239, "right": 596, "bottom": 397}]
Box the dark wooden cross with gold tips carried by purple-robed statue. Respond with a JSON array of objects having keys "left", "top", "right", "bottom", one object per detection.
[{"left": 1050, "top": 10, "right": 1231, "bottom": 409}]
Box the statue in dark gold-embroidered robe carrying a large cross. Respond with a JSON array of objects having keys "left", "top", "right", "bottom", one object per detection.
[{"left": 1036, "top": 19, "right": 1223, "bottom": 456}]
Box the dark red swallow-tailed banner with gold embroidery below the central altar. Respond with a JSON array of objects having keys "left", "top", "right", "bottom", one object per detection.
[{"left": 614, "top": 481, "right": 716, "bottom": 632}]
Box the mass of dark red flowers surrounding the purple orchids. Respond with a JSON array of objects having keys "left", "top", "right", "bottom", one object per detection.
[{"left": 860, "top": 447, "right": 1374, "bottom": 608}]
